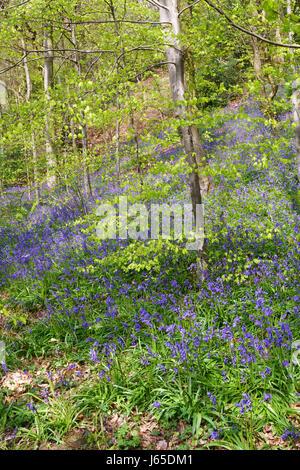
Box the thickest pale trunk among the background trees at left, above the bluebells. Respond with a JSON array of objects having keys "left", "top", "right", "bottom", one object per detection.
[{"left": 44, "top": 27, "right": 57, "bottom": 188}]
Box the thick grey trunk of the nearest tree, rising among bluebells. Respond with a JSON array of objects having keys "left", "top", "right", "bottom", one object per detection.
[{"left": 159, "top": 0, "right": 206, "bottom": 280}]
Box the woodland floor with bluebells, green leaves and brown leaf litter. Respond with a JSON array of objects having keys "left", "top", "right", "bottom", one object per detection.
[{"left": 0, "top": 99, "right": 300, "bottom": 450}]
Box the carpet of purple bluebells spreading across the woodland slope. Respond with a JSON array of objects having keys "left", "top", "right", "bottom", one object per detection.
[{"left": 0, "top": 99, "right": 300, "bottom": 439}]
